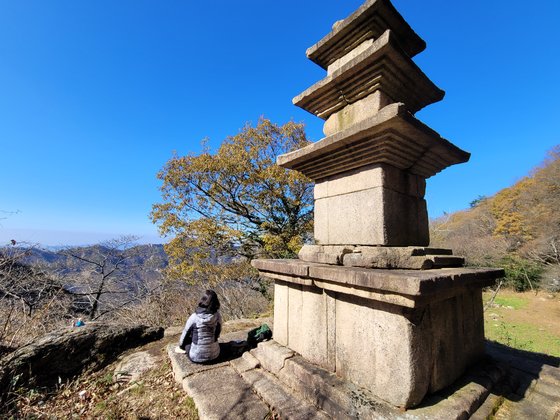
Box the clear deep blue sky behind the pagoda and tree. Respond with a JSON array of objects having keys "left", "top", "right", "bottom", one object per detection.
[{"left": 0, "top": 0, "right": 560, "bottom": 245}]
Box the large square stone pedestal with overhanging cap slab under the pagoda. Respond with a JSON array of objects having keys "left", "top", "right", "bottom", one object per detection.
[{"left": 253, "top": 260, "right": 503, "bottom": 407}]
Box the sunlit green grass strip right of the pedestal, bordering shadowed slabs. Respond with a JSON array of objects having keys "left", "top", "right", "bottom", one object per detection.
[{"left": 484, "top": 319, "right": 560, "bottom": 357}]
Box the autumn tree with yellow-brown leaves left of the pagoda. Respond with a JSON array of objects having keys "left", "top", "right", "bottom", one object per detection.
[{"left": 151, "top": 118, "right": 313, "bottom": 284}]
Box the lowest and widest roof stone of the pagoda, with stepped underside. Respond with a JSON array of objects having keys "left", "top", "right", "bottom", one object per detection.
[{"left": 277, "top": 103, "right": 470, "bottom": 181}]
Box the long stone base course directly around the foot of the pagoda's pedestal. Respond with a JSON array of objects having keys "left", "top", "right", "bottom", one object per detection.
[{"left": 247, "top": 341, "right": 520, "bottom": 419}]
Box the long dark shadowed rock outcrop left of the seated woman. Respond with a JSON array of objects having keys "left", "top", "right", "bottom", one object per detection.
[{"left": 0, "top": 324, "right": 164, "bottom": 402}]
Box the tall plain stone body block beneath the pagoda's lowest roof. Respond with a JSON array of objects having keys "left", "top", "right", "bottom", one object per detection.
[{"left": 314, "top": 164, "right": 430, "bottom": 246}]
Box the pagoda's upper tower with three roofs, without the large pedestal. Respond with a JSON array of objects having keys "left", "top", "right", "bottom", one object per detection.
[{"left": 277, "top": 0, "right": 470, "bottom": 249}]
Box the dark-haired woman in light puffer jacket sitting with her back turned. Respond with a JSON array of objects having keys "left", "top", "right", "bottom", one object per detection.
[{"left": 179, "top": 290, "right": 222, "bottom": 363}]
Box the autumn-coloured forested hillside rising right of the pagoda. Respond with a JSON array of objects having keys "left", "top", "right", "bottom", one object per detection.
[{"left": 431, "top": 146, "right": 560, "bottom": 290}]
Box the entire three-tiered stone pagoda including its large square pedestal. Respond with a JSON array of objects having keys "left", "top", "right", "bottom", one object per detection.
[{"left": 253, "top": 0, "right": 503, "bottom": 407}]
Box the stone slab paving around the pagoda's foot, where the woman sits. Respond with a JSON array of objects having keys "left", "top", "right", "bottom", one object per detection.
[{"left": 167, "top": 324, "right": 560, "bottom": 420}]
